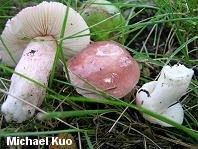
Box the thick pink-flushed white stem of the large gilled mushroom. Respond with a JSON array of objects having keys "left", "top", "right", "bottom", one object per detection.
[{"left": 1, "top": 36, "right": 57, "bottom": 123}]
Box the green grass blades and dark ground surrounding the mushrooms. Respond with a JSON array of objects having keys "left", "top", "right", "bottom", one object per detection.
[{"left": 0, "top": 0, "right": 198, "bottom": 149}]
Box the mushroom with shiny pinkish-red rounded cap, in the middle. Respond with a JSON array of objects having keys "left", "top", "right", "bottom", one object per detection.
[{"left": 67, "top": 41, "right": 140, "bottom": 99}]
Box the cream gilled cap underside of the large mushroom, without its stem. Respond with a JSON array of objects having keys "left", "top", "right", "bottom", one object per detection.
[{"left": 0, "top": 2, "right": 90, "bottom": 66}]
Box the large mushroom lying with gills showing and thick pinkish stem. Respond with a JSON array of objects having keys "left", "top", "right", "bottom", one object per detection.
[{"left": 0, "top": 2, "right": 90, "bottom": 123}]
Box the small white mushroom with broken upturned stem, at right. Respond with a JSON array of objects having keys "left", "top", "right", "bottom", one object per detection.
[{"left": 136, "top": 64, "right": 194, "bottom": 127}]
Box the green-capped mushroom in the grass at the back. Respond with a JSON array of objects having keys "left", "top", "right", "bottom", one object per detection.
[{"left": 80, "top": 0, "right": 127, "bottom": 42}]
